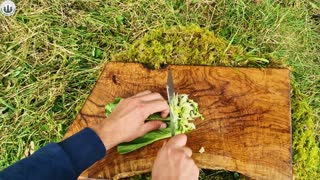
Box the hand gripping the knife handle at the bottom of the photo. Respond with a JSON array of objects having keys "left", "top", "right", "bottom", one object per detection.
[{"left": 152, "top": 134, "right": 199, "bottom": 180}]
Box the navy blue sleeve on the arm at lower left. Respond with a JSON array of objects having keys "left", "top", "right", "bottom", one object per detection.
[{"left": 0, "top": 128, "right": 106, "bottom": 180}]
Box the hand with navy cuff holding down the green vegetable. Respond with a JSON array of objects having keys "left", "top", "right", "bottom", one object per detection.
[{"left": 92, "top": 91, "right": 169, "bottom": 149}]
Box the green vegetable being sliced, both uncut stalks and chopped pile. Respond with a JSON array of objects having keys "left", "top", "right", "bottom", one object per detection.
[{"left": 105, "top": 94, "right": 203, "bottom": 154}]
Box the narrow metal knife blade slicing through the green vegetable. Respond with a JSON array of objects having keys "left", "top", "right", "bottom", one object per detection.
[{"left": 167, "top": 69, "right": 176, "bottom": 137}]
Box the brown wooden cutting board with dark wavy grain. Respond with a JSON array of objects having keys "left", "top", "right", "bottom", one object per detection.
[{"left": 65, "top": 63, "right": 292, "bottom": 179}]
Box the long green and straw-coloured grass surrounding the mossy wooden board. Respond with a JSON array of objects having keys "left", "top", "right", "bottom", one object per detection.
[{"left": 0, "top": 0, "right": 320, "bottom": 179}]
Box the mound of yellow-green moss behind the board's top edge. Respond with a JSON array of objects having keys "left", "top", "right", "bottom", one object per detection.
[{"left": 112, "top": 25, "right": 281, "bottom": 69}]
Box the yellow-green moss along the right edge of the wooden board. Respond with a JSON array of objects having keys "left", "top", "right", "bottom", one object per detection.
[{"left": 291, "top": 80, "right": 320, "bottom": 179}]
